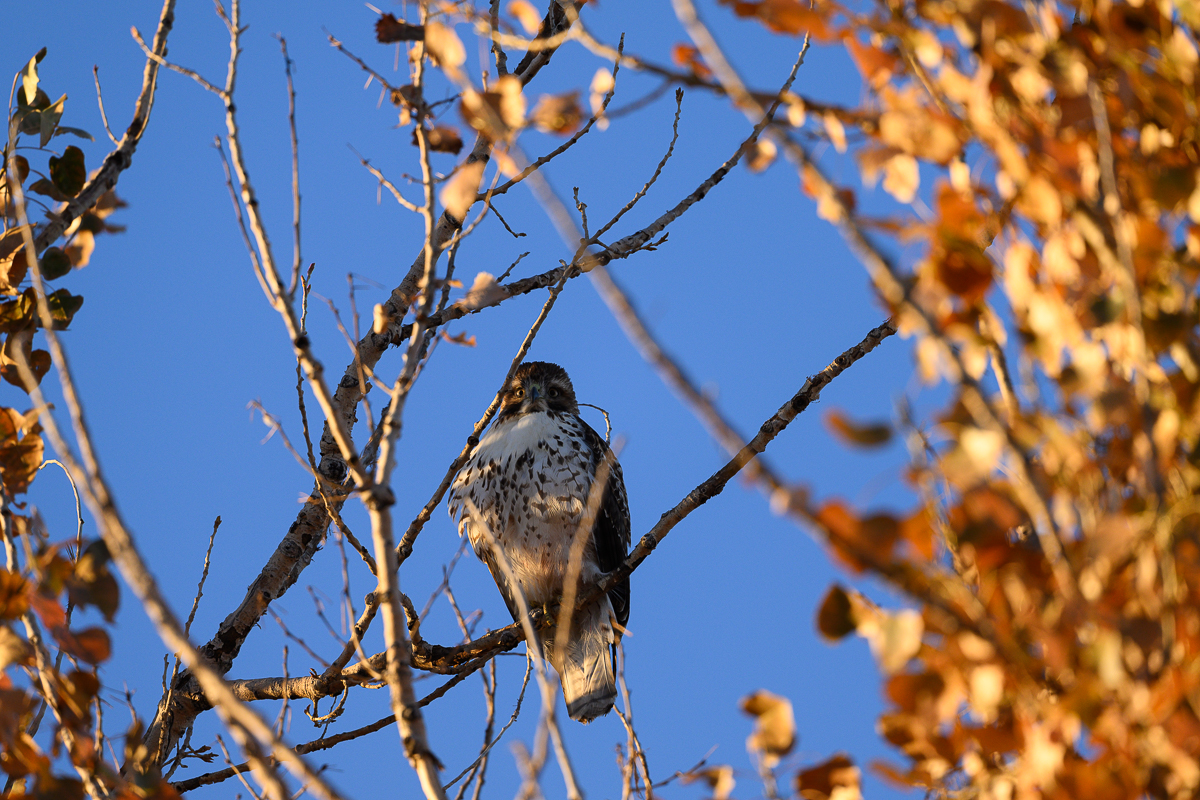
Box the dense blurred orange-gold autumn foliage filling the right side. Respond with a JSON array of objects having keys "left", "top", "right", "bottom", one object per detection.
[{"left": 724, "top": 0, "right": 1200, "bottom": 800}]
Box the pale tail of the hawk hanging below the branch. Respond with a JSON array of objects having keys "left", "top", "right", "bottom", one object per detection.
[{"left": 542, "top": 597, "right": 617, "bottom": 722}]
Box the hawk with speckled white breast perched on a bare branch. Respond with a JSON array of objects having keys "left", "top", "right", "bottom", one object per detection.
[{"left": 448, "top": 361, "right": 630, "bottom": 722}]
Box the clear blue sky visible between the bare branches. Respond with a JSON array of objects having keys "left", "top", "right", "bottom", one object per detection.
[{"left": 14, "top": 0, "right": 914, "bottom": 798}]
